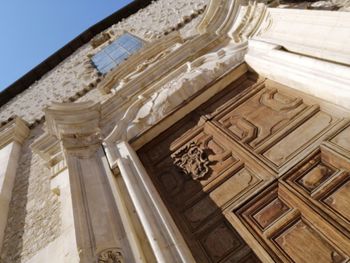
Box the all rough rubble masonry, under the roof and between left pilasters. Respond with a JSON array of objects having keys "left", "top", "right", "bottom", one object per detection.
[{"left": 0, "top": 0, "right": 207, "bottom": 263}]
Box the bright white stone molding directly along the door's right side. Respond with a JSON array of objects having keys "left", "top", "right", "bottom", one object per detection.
[{"left": 245, "top": 40, "right": 350, "bottom": 109}]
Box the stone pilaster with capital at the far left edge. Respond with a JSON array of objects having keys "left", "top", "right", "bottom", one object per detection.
[{"left": 0, "top": 118, "right": 29, "bottom": 250}]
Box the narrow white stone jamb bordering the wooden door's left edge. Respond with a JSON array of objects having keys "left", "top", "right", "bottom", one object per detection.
[{"left": 109, "top": 141, "right": 195, "bottom": 263}]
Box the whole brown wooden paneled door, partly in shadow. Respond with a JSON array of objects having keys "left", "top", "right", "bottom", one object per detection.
[{"left": 138, "top": 76, "right": 350, "bottom": 263}]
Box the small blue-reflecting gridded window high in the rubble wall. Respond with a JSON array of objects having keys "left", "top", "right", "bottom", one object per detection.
[{"left": 91, "top": 33, "right": 143, "bottom": 74}]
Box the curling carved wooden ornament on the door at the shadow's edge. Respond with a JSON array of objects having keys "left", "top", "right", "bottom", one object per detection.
[{"left": 171, "top": 142, "right": 210, "bottom": 180}]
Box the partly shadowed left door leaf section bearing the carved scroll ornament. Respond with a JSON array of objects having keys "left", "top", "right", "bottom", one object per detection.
[{"left": 139, "top": 114, "right": 264, "bottom": 262}]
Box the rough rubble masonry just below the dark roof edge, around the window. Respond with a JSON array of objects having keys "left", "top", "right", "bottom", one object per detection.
[{"left": 0, "top": 0, "right": 209, "bottom": 127}]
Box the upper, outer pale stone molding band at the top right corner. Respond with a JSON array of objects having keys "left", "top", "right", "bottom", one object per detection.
[{"left": 253, "top": 8, "right": 350, "bottom": 66}]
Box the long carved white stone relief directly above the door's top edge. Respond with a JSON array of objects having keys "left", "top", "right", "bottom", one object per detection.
[{"left": 106, "top": 43, "right": 247, "bottom": 144}]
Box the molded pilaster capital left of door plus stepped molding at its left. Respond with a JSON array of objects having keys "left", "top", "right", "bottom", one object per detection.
[{"left": 31, "top": 102, "right": 101, "bottom": 177}]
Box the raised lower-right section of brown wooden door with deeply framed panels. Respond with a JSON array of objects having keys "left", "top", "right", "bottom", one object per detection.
[{"left": 229, "top": 141, "right": 350, "bottom": 263}]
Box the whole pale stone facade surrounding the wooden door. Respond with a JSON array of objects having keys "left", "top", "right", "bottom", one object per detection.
[{"left": 0, "top": 0, "right": 350, "bottom": 263}]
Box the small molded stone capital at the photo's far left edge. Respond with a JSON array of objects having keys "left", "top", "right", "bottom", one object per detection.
[{"left": 0, "top": 117, "right": 30, "bottom": 149}]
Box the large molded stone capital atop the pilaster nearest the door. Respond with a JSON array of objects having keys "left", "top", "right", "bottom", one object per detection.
[{"left": 45, "top": 101, "right": 101, "bottom": 157}]
